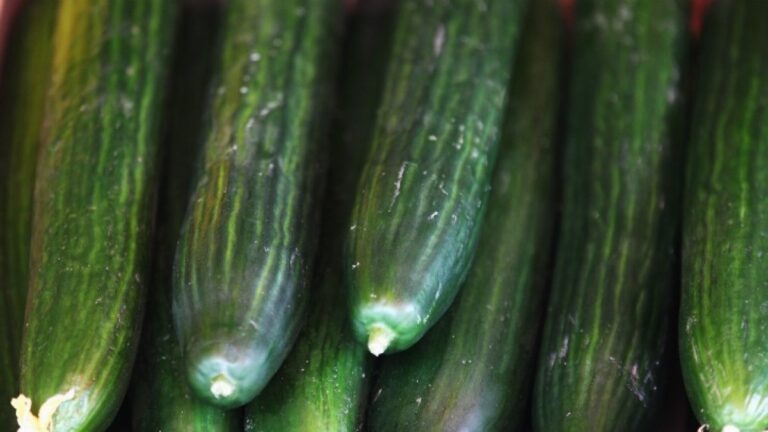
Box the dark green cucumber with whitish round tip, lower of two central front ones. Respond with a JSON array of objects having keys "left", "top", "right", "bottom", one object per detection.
[{"left": 173, "top": 0, "right": 341, "bottom": 408}]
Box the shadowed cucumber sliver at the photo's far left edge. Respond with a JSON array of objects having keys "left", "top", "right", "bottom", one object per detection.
[{"left": 0, "top": 0, "right": 56, "bottom": 430}]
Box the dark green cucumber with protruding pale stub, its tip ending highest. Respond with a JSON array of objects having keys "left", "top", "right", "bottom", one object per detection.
[{"left": 345, "top": 0, "right": 523, "bottom": 355}]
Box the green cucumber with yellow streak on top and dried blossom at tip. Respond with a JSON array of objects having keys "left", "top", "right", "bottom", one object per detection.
[{"left": 13, "top": 0, "right": 173, "bottom": 432}]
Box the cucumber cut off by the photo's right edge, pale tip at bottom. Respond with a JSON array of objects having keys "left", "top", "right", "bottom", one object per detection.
[{"left": 679, "top": 0, "right": 768, "bottom": 432}]
